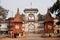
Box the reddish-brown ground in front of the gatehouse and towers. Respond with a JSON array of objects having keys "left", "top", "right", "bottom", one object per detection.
[{"left": 0, "top": 33, "right": 60, "bottom": 40}]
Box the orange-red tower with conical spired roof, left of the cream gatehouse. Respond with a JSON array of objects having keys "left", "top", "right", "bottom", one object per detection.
[{"left": 14, "top": 9, "right": 22, "bottom": 33}]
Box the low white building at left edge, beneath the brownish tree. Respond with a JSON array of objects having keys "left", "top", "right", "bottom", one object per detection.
[{"left": 0, "top": 20, "right": 8, "bottom": 34}]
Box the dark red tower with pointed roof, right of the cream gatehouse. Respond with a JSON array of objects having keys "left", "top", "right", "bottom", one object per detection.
[{"left": 45, "top": 9, "right": 54, "bottom": 33}]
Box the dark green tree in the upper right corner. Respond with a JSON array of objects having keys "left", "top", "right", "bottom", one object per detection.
[{"left": 50, "top": 0, "right": 60, "bottom": 19}]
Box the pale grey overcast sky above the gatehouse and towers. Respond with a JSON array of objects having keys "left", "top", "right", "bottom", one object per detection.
[{"left": 0, "top": 0, "right": 56, "bottom": 17}]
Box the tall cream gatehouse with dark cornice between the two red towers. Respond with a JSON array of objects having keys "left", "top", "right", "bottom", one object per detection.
[{"left": 23, "top": 8, "right": 39, "bottom": 32}]
